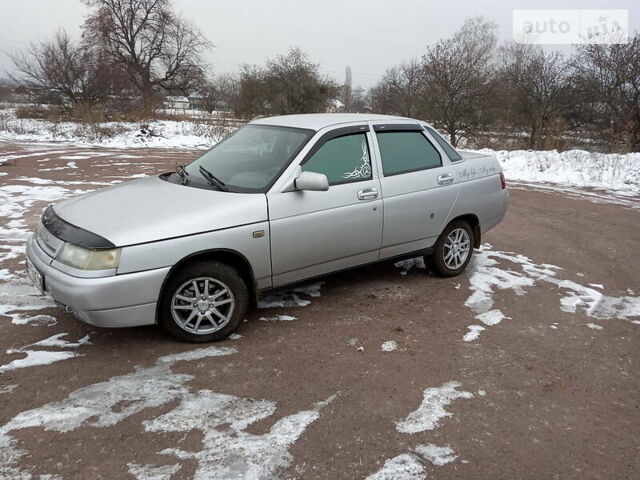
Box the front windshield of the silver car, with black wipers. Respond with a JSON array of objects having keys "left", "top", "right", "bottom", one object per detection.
[{"left": 185, "top": 125, "right": 314, "bottom": 192}]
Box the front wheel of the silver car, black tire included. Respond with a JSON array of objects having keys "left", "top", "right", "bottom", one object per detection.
[{"left": 158, "top": 260, "right": 249, "bottom": 342}]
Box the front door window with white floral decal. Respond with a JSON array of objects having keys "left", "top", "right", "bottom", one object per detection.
[{"left": 302, "top": 133, "right": 371, "bottom": 185}]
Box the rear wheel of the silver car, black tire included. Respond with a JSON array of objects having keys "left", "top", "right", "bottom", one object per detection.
[{"left": 425, "top": 220, "right": 474, "bottom": 277}]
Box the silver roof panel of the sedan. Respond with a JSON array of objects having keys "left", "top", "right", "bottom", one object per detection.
[{"left": 251, "top": 113, "right": 418, "bottom": 130}]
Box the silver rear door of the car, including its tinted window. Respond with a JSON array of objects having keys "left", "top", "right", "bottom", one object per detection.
[{"left": 374, "top": 124, "right": 459, "bottom": 258}]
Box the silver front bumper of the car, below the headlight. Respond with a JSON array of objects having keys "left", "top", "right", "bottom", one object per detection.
[{"left": 27, "top": 236, "right": 170, "bottom": 327}]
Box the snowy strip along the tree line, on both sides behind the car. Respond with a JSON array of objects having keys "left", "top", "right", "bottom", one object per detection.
[{"left": 0, "top": 109, "right": 640, "bottom": 195}]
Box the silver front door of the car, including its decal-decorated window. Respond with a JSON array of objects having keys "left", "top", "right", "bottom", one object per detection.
[{"left": 267, "top": 125, "right": 383, "bottom": 286}]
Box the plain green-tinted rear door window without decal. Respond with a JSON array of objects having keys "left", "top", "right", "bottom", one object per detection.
[{"left": 376, "top": 132, "right": 442, "bottom": 176}]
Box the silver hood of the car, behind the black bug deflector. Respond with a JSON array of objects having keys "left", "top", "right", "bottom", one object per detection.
[{"left": 53, "top": 177, "right": 267, "bottom": 247}]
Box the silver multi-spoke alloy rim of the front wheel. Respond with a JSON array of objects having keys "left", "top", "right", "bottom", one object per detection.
[{"left": 171, "top": 277, "right": 236, "bottom": 335}]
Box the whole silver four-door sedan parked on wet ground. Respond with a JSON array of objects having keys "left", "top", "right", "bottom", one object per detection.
[{"left": 27, "top": 114, "right": 508, "bottom": 342}]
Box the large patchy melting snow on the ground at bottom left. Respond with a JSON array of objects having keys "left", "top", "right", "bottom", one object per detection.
[{"left": 0, "top": 348, "right": 336, "bottom": 480}]
